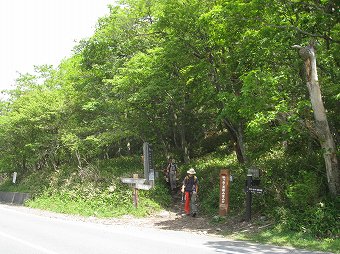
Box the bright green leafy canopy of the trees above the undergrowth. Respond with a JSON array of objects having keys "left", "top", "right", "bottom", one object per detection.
[{"left": 1, "top": 0, "right": 339, "bottom": 182}]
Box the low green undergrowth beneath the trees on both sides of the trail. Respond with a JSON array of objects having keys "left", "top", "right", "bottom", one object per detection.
[{"left": 0, "top": 151, "right": 340, "bottom": 251}]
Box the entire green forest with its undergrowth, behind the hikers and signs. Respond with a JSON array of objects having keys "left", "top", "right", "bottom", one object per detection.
[{"left": 0, "top": 0, "right": 340, "bottom": 252}]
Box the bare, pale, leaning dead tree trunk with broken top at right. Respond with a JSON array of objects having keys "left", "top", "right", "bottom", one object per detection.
[{"left": 293, "top": 44, "right": 340, "bottom": 196}]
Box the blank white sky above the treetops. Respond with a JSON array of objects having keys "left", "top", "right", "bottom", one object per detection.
[{"left": 0, "top": 0, "right": 114, "bottom": 90}]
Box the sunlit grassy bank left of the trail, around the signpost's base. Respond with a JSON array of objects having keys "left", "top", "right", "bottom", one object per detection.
[{"left": 0, "top": 156, "right": 170, "bottom": 218}]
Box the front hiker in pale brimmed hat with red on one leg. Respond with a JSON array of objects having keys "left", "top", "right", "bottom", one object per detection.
[{"left": 181, "top": 168, "right": 198, "bottom": 217}]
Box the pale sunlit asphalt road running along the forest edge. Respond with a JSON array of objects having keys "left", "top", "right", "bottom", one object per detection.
[{"left": 0, "top": 204, "right": 332, "bottom": 254}]
